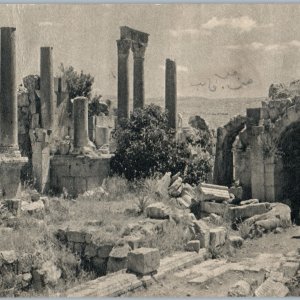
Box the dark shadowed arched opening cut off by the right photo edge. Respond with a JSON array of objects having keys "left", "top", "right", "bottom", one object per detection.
[{"left": 278, "top": 122, "right": 300, "bottom": 225}]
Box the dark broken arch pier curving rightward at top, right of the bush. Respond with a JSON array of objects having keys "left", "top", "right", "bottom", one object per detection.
[{"left": 214, "top": 116, "right": 246, "bottom": 186}]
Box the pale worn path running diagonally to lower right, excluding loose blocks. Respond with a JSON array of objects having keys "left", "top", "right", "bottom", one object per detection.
[{"left": 126, "top": 226, "right": 300, "bottom": 297}]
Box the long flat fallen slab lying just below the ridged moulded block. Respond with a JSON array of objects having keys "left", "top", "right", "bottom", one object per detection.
[{"left": 226, "top": 203, "right": 270, "bottom": 220}]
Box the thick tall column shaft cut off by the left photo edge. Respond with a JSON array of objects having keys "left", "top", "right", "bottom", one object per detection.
[{"left": 0, "top": 27, "right": 19, "bottom": 152}]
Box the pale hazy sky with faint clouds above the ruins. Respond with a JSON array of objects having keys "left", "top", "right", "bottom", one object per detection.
[{"left": 0, "top": 4, "right": 300, "bottom": 98}]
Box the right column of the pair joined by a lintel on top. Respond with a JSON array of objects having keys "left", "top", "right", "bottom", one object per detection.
[{"left": 132, "top": 42, "right": 147, "bottom": 110}]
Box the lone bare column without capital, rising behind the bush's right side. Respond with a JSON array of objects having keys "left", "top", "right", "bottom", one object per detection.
[{"left": 165, "top": 59, "right": 177, "bottom": 130}]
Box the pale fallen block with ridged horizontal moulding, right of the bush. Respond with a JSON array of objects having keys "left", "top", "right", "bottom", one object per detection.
[{"left": 199, "top": 183, "right": 230, "bottom": 202}]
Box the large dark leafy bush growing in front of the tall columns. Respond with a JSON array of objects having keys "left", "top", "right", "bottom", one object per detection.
[{"left": 111, "top": 104, "right": 211, "bottom": 184}]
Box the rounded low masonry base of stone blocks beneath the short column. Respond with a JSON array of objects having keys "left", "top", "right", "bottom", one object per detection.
[{"left": 50, "top": 155, "right": 111, "bottom": 197}]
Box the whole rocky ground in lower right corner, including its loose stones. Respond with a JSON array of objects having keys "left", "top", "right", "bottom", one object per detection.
[{"left": 126, "top": 226, "right": 300, "bottom": 297}]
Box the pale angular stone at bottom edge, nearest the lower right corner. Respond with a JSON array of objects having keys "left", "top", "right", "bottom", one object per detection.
[{"left": 254, "top": 278, "right": 289, "bottom": 297}]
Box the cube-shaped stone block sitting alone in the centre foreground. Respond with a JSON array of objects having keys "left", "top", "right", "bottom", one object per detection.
[{"left": 127, "top": 248, "right": 160, "bottom": 275}]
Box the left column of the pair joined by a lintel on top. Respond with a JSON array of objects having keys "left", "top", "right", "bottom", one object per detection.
[{"left": 117, "top": 39, "right": 131, "bottom": 121}]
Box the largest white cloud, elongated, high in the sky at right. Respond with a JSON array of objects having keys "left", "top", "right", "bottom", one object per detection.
[{"left": 202, "top": 16, "right": 273, "bottom": 32}]
